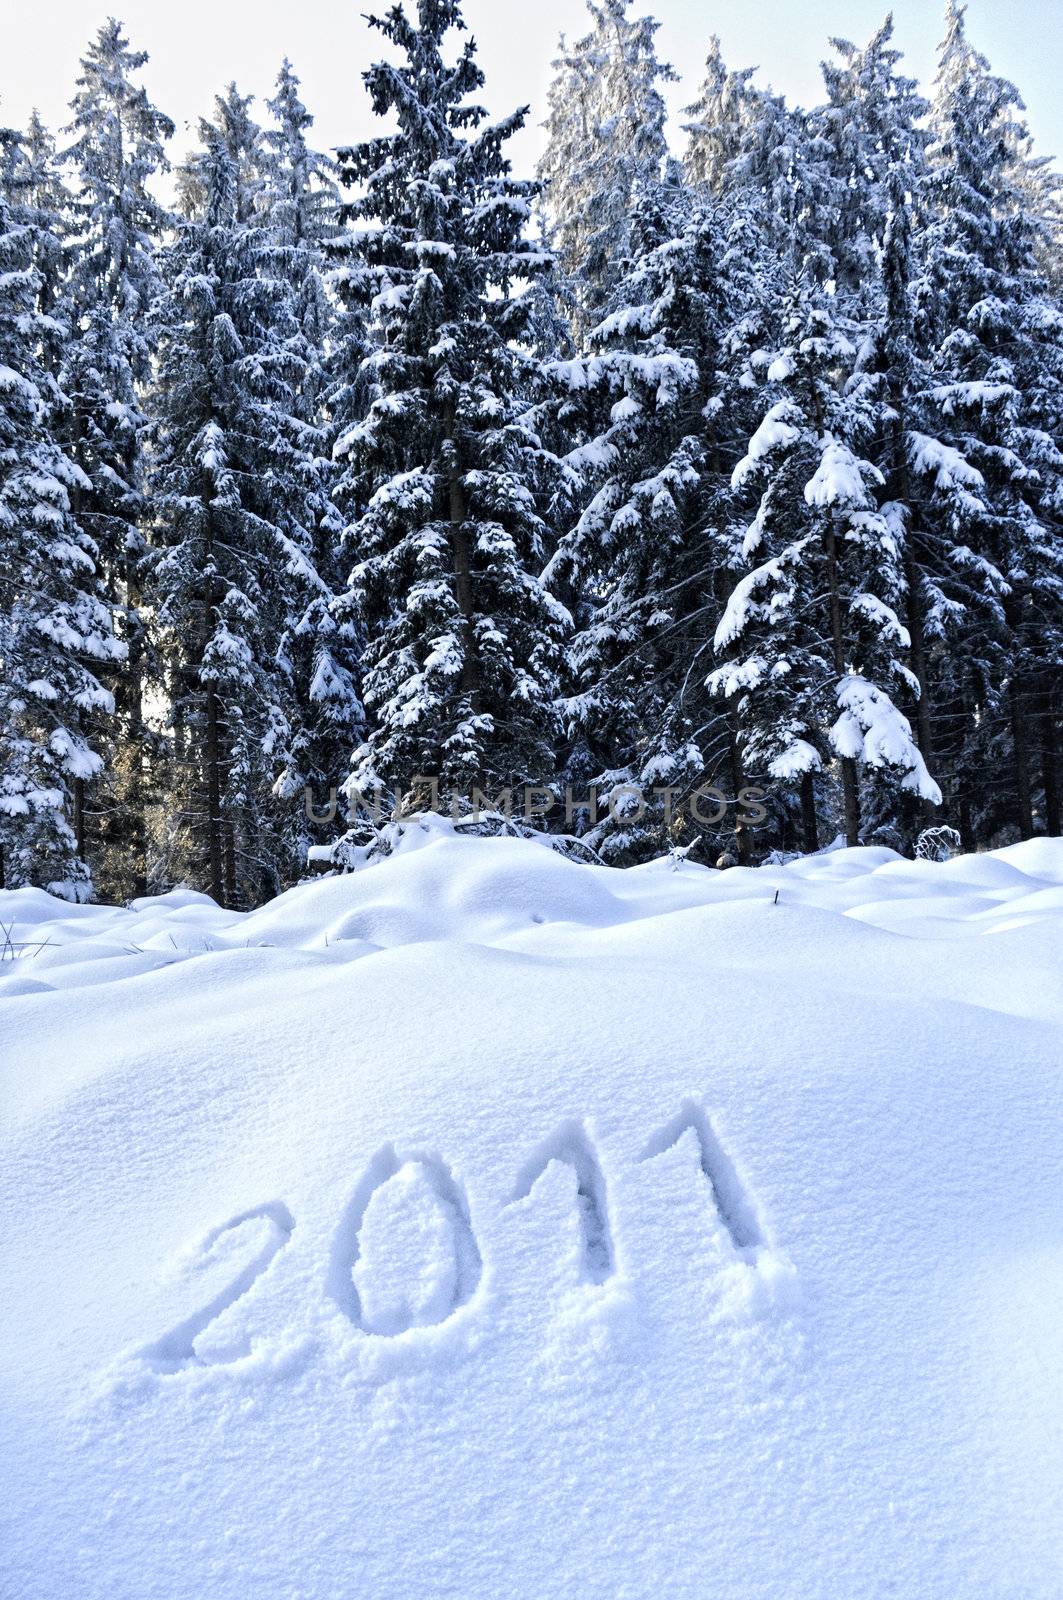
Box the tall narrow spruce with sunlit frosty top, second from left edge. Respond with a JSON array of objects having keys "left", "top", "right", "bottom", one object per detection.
[{"left": 62, "top": 18, "right": 173, "bottom": 899}]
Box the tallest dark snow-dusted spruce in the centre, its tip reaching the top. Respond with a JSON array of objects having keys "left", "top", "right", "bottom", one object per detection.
[{"left": 338, "top": 0, "right": 567, "bottom": 812}]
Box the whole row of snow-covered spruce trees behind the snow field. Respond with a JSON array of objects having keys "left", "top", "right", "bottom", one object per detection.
[{"left": 0, "top": 0, "right": 1063, "bottom": 906}]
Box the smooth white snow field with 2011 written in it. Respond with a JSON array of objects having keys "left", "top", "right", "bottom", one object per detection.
[{"left": 0, "top": 821, "right": 1063, "bottom": 1600}]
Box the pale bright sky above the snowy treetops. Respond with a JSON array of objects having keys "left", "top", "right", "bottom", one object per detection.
[{"left": 0, "top": 0, "right": 1063, "bottom": 176}]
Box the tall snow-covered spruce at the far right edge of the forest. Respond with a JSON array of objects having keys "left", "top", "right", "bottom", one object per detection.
[{"left": 919, "top": 0, "right": 1063, "bottom": 838}]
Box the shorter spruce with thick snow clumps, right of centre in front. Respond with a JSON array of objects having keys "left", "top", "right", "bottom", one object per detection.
[{"left": 709, "top": 272, "right": 940, "bottom": 845}]
